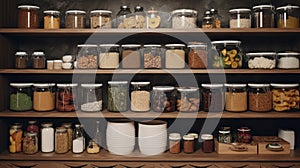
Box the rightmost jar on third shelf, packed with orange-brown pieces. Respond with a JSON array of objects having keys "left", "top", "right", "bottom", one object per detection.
[{"left": 271, "top": 83, "right": 300, "bottom": 111}]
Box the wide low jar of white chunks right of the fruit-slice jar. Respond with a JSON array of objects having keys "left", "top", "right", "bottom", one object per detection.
[{"left": 246, "top": 52, "right": 276, "bottom": 69}]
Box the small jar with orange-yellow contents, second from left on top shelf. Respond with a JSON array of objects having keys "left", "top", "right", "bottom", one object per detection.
[{"left": 44, "top": 10, "right": 60, "bottom": 29}]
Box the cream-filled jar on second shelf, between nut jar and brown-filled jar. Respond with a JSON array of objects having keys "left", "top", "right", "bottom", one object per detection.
[{"left": 99, "top": 44, "right": 120, "bottom": 69}]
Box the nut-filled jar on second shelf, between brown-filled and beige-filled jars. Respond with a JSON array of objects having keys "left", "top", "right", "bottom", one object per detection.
[{"left": 144, "top": 44, "right": 163, "bottom": 69}]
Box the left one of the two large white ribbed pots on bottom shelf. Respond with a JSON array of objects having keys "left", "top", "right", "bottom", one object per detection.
[{"left": 106, "top": 120, "right": 135, "bottom": 155}]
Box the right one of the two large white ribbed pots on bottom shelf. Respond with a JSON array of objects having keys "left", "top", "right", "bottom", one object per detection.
[{"left": 138, "top": 120, "right": 167, "bottom": 155}]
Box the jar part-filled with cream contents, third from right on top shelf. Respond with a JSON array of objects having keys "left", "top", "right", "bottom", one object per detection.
[{"left": 229, "top": 8, "right": 251, "bottom": 28}]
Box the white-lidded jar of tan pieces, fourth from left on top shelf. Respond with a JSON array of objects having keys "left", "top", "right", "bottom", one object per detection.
[{"left": 90, "top": 10, "right": 112, "bottom": 29}]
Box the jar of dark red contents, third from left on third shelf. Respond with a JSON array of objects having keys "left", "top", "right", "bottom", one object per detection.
[{"left": 56, "top": 83, "right": 78, "bottom": 112}]
